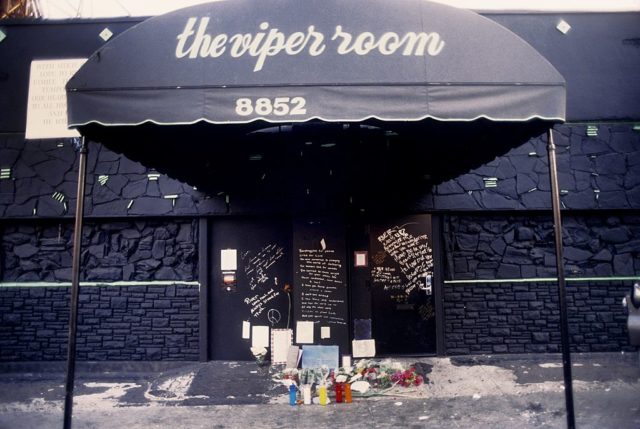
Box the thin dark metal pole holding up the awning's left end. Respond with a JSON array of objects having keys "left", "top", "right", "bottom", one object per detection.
[{"left": 64, "top": 137, "right": 87, "bottom": 429}]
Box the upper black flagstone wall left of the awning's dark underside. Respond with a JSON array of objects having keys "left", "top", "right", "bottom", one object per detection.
[{"left": 0, "top": 134, "right": 226, "bottom": 218}]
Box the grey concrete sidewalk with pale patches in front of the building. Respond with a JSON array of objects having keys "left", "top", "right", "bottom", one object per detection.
[{"left": 0, "top": 353, "right": 640, "bottom": 429}]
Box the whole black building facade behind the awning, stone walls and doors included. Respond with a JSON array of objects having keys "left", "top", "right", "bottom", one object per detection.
[{"left": 0, "top": 7, "right": 640, "bottom": 361}]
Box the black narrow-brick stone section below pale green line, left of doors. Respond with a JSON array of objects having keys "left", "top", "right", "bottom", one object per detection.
[{"left": 0, "top": 285, "right": 199, "bottom": 361}]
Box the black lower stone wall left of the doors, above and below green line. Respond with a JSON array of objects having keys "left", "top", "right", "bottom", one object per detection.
[{"left": 0, "top": 219, "right": 199, "bottom": 361}]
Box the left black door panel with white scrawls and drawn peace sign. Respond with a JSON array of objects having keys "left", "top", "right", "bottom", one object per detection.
[{"left": 209, "top": 218, "right": 293, "bottom": 360}]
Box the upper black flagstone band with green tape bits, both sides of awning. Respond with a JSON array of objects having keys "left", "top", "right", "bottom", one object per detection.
[{"left": 0, "top": 124, "right": 640, "bottom": 218}]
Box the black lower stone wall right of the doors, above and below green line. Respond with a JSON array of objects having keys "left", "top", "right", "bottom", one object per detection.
[{"left": 444, "top": 213, "right": 640, "bottom": 354}]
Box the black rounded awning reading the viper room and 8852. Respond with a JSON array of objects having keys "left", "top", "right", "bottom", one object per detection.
[{"left": 67, "top": 0, "right": 565, "bottom": 129}]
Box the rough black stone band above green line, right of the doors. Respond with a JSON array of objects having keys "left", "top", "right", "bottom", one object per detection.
[{"left": 444, "top": 212, "right": 640, "bottom": 280}]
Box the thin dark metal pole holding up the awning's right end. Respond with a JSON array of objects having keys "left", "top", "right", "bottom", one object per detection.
[{"left": 547, "top": 128, "right": 576, "bottom": 429}]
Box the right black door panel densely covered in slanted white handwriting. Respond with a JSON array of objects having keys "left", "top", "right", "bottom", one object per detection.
[{"left": 352, "top": 215, "right": 436, "bottom": 355}]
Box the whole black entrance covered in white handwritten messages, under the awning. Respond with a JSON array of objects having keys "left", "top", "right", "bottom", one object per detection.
[{"left": 209, "top": 215, "right": 438, "bottom": 360}]
